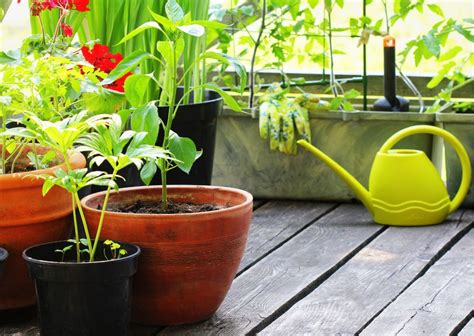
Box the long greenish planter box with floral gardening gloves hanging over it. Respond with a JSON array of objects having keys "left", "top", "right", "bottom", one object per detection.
[{"left": 212, "top": 111, "right": 435, "bottom": 201}]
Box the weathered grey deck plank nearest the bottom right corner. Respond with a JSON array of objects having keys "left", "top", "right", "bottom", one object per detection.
[{"left": 362, "top": 222, "right": 474, "bottom": 335}]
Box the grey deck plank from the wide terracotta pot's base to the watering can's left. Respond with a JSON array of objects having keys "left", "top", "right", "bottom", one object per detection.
[{"left": 158, "top": 204, "right": 384, "bottom": 336}]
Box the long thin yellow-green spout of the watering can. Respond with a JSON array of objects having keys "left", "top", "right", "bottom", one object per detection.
[{"left": 297, "top": 140, "right": 373, "bottom": 214}]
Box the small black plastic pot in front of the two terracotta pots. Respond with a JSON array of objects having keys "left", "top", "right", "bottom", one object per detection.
[{"left": 23, "top": 241, "right": 140, "bottom": 336}]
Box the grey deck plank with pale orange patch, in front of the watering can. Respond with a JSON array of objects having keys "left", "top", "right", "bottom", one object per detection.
[{"left": 261, "top": 212, "right": 472, "bottom": 335}]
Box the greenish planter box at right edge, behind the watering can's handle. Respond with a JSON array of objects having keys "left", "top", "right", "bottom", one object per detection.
[{"left": 433, "top": 113, "right": 474, "bottom": 208}]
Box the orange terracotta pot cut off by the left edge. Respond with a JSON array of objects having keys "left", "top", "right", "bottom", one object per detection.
[{"left": 0, "top": 146, "right": 86, "bottom": 310}]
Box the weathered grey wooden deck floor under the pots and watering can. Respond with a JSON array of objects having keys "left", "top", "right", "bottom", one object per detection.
[{"left": 0, "top": 201, "right": 474, "bottom": 336}]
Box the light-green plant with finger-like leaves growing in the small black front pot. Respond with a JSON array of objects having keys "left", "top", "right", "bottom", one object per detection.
[{"left": 0, "top": 111, "right": 171, "bottom": 262}]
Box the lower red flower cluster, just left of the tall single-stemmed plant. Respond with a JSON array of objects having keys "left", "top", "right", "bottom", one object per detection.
[{"left": 81, "top": 44, "right": 132, "bottom": 92}]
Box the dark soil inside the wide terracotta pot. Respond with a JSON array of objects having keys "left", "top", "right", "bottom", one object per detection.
[{"left": 105, "top": 201, "right": 225, "bottom": 214}]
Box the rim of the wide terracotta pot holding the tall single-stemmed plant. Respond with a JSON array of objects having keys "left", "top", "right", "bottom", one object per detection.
[{"left": 81, "top": 184, "right": 253, "bottom": 219}]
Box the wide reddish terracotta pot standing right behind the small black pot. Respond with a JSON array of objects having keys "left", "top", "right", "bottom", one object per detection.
[{"left": 82, "top": 186, "right": 252, "bottom": 325}]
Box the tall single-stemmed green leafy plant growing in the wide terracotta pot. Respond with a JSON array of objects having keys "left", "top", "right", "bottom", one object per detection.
[{"left": 102, "top": 0, "right": 246, "bottom": 209}]
